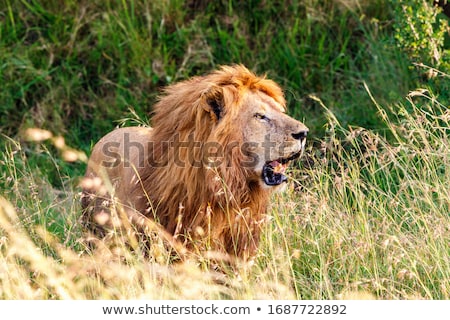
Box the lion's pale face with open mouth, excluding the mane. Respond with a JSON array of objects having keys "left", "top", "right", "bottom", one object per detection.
[{"left": 239, "top": 92, "right": 308, "bottom": 187}]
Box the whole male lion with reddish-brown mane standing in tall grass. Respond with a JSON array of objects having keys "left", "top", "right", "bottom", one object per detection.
[{"left": 82, "top": 65, "right": 308, "bottom": 259}]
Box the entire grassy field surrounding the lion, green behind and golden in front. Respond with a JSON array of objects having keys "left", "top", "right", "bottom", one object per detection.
[{"left": 0, "top": 0, "right": 450, "bottom": 299}]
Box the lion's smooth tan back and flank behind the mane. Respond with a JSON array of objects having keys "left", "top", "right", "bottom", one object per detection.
[{"left": 82, "top": 127, "right": 153, "bottom": 230}]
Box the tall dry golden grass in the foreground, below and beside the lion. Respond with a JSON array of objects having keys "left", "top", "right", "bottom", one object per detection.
[{"left": 0, "top": 88, "right": 450, "bottom": 299}]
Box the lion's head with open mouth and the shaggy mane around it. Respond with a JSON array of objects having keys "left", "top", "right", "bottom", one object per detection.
[{"left": 149, "top": 65, "right": 308, "bottom": 194}]
